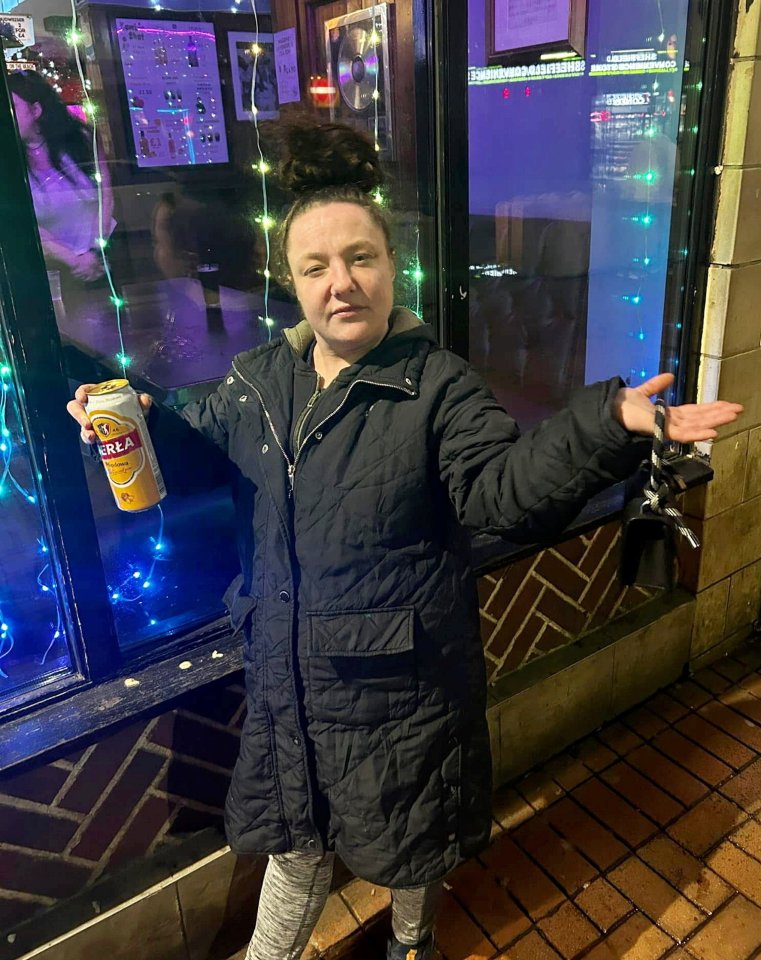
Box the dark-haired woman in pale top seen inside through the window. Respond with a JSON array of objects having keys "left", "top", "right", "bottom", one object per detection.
[{"left": 8, "top": 70, "right": 115, "bottom": 282}]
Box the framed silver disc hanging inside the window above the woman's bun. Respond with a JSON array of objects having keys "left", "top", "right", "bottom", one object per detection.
[{"left": 325, "top": 3, "right": 395, "bottom": 160}]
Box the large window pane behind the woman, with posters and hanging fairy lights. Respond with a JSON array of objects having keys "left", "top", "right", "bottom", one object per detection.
[{"left": 5, "top": 0, "right": 431, "bottom": 648}]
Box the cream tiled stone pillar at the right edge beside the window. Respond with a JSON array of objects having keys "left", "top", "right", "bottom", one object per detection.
[{"left": 685, "top": 0, "right": 761, "bottom": 669}]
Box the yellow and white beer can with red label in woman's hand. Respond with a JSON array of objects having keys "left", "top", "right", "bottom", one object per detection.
[{"left": 86, "top": 380, "right": 166, "bottom": 513}]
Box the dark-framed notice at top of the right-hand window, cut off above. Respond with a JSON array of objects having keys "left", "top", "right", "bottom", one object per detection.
[{"left": 486, "top": 0, "right": 587, "bottom": 66}]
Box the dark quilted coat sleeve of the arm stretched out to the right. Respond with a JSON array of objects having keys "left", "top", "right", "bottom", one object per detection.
[{"left": 434, "top": 365, "right": 649, "bottom": 543}]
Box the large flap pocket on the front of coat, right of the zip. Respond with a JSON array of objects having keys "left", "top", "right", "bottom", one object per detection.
[{"left": 307, "top": 607, "right": 418, "bottom": 727}]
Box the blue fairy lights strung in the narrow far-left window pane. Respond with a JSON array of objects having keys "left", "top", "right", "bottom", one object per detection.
[{"left": 0, "top": 338, "right": 63, "bottom": 680}]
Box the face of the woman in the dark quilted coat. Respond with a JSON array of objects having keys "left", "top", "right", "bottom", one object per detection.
[{"left": 286, "top": 202, "right": 396, "bottom": 361}]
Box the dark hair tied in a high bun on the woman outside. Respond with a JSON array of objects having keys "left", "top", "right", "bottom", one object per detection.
[{"left": 274, "top": 120, "right": 393, "bottom": 286}]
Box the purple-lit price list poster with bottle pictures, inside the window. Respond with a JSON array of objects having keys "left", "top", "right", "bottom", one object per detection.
[{"left": 116, "top": 19, "right": 228, "bottom": 167}]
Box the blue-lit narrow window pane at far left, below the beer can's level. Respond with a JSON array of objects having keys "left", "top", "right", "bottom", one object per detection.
[{"left": 0, "top": 317, "right": 72, "bottom": 701}]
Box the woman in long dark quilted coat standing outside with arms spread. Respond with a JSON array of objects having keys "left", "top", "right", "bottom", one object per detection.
[{"left": 69, "top": 125, "right": 740, "bottom": 960}]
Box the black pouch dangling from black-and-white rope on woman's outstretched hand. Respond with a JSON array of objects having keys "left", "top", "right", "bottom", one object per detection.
[{"left": 619, "top": 399, "right": 700, "bottom": 590}]
